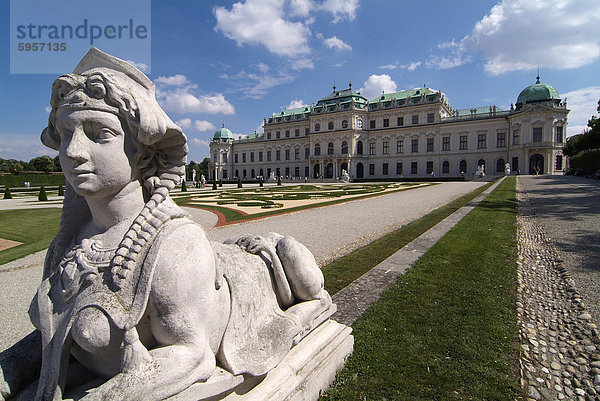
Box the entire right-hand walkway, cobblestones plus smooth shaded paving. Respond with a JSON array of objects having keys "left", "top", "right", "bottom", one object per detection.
[{"left": 517, "top": 176, "right": 600, "bottom": 401}]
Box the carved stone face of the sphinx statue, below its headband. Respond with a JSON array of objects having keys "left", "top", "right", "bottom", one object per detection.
[{"left": 55, "top": 110, "right": 137, "bottom": 197}]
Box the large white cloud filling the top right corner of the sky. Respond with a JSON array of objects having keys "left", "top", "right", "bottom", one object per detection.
[{"left": 460, "top": 0, "right": 600, "bottom": 75}]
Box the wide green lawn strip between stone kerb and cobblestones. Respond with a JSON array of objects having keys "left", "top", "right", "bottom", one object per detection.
[{"left": 323, "top": 177, "right": 521, "bottom": 401}]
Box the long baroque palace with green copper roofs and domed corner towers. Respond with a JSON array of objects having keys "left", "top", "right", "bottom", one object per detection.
[{"left": 209, "top": 76, "right": 569, "bottom": 180}]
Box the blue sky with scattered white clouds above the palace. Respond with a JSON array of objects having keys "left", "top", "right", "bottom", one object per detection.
[{"left": 0, "top": 0, "right": 600, "bottom": 161}]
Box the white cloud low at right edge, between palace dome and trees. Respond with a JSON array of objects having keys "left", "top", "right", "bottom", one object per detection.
[{"left": 561, "top": 86, "right": 600, "bottom": 136}]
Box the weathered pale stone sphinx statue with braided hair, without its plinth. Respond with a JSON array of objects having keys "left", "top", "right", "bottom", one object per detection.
[{"left": 0, "top": 48, "right": 335, "bottom": 401}]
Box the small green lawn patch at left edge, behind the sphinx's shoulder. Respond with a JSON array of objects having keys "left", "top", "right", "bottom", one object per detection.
[{"left": 0, "top": 208, "right": 61, "bottom": 265}]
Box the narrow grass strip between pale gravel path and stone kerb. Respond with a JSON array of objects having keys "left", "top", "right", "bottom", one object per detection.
[{"left": 322, "top": 183, "right": 492, "bottom": 295}]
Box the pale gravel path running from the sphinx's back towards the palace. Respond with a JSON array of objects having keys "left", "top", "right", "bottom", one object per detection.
[{"left": 198, "top": 181, "right": 485, "bottom": 266}]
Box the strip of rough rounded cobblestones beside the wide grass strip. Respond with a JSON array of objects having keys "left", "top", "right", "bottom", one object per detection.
[{"left": 517, "top": 184, "right": 600, "bottom": 401}]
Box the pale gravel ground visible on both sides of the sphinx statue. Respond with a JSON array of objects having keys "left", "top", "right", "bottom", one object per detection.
[{"left": 0, "top": 181, "right": 485, "bottom": 351}]
